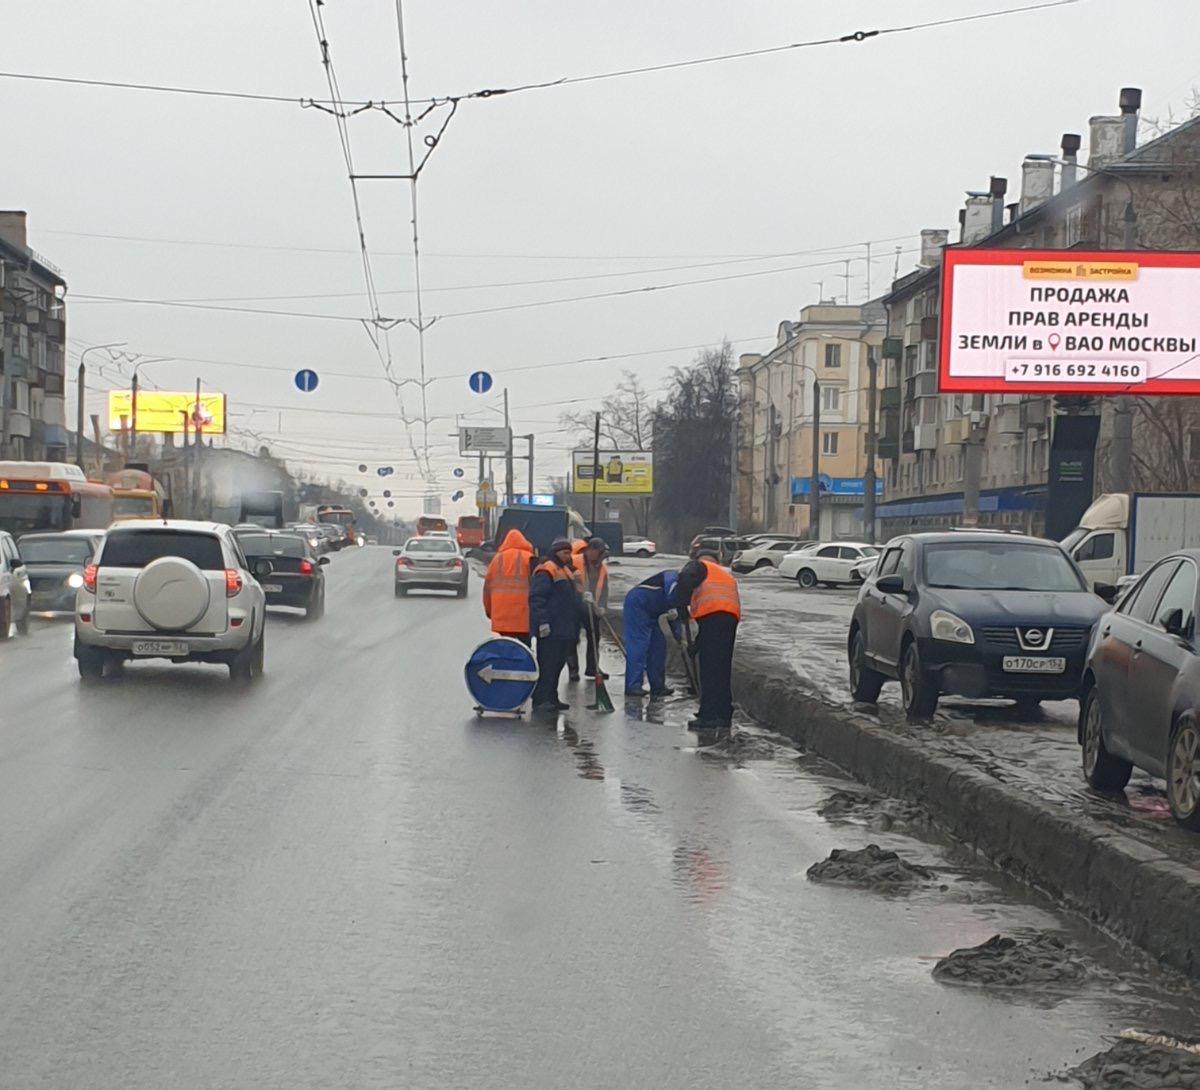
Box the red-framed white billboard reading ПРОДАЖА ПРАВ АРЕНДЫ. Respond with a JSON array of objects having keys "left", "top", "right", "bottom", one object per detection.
[{"left": 938, "top": 247, "right": 1200, "bottom": 394}]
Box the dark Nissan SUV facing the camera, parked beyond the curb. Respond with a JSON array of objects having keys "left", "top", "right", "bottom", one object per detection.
[{"left": 846, "top": 531, "right": 1108, "bottom": 719}]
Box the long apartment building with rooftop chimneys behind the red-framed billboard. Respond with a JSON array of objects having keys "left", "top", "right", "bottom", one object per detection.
[{"left": 878, "top": 88, "right": 1200, "bottom": 539}]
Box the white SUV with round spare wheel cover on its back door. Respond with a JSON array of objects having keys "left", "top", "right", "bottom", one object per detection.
[{"left": 74, "top": 520, "right": 271, "bottom": 681}]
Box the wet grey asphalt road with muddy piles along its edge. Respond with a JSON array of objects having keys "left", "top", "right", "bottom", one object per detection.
[{"left": 0, "top": 549, "right": 1195, "bottom": 1090}]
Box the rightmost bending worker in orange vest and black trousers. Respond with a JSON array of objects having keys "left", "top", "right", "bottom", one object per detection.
[{"left": 676, "top": 550, "right": 742, "bottom": 735}]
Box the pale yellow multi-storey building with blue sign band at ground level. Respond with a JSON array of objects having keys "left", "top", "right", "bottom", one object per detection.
[{"left": 738, "top": 303, "right": 884, "bottom": 539}]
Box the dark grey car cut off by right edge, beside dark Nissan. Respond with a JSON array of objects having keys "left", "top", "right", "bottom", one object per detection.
[{"left": 1079, "top": 549, "right": 1200, "bottom": 830}]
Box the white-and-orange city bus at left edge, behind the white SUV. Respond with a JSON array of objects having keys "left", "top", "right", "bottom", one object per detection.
[{"left": 0, "top": 462, "right": 113, "bottom": 537}]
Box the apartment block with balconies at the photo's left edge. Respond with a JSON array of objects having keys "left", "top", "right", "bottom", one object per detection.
[{"left": 0, "top": 211, "right": 67, "bottom": 461}]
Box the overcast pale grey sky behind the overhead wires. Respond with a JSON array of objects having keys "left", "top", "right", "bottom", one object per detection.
[{"left": 0, "top": 0, "right": 1200, "bottom": 514}]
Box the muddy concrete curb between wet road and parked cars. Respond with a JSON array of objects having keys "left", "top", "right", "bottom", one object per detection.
[{"left": 614, "top": 595, "right": 1200, "bottom": 980}]
